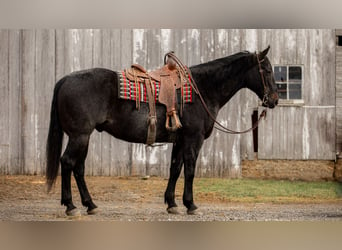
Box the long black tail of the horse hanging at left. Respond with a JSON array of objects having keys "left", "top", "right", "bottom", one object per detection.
[{"left": 46, "top": 78, "right": 65, "bottom": 192}]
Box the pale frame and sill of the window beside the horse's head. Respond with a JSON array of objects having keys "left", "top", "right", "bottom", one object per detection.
[{"left": 272, "top": 64, "right": 305, "bottom": 106}]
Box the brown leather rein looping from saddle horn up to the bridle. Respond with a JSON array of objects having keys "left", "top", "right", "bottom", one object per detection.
[{"left": 164, "top": 51, "right": 268, "bottom": 134}]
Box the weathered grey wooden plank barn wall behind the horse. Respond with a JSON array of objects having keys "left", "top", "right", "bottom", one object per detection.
[{"left": 0, "top": 29, "right": 335, "bottom": 177}]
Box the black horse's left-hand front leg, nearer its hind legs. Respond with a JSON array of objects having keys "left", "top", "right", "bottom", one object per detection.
[{"left": 164, "top": 142, "right": 183, "bottom": 214}]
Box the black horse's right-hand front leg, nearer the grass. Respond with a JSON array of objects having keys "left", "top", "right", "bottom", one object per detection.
[{"left": 183, "top": 136, "right": 204, "bottom": 214}]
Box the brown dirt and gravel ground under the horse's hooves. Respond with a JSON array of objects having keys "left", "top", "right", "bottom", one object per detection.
[{"left": 0, "top": 176, "right": 342, "bottom": 221}]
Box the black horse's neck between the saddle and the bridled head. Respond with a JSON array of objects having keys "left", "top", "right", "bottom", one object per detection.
[{"left": 191, "top": 56, "right": 251, "bottom": 110}]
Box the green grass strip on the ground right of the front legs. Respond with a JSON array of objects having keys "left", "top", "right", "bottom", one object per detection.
[{"left": 194, "top": 178, "right": 342, "bottom": 203}]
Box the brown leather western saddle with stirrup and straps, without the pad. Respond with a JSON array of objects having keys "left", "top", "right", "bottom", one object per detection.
[{"left": 125, "top": 52, "right": 188, "bottom": 145}]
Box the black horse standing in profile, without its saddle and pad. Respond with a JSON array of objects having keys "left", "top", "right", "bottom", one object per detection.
[{"left": 46, "top": 47, "right": 278, "bottom": 215}]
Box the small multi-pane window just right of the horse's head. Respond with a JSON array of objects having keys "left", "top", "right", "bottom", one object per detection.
[{"left": 273, "top": 65, "right": 303, "bottom": 100}]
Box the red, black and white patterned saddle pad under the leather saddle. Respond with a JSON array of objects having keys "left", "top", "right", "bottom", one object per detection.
[{"left": 117, "top": 71, "right": 192, "bottom": 103}]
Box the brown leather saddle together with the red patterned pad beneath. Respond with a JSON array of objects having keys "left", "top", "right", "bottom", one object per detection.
[{"left": 119, "top": 52, "right": 192, "bottom": 145}]
